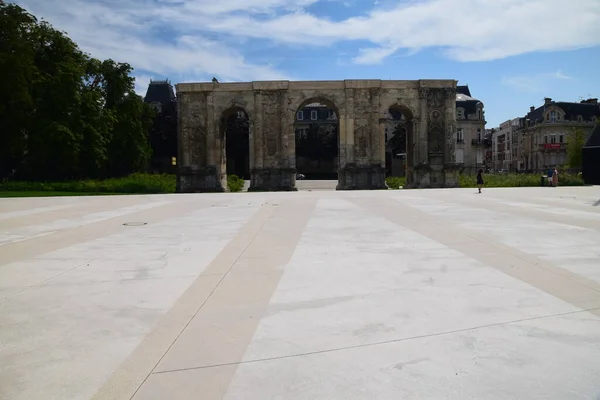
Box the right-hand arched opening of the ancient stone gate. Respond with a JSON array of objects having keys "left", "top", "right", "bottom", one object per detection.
[{"left": 385, "top": 104, "right": 414, "bottom": 186}]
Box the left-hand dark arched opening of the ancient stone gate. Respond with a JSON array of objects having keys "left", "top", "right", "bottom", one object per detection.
[{"left": 220, "top": 107, "right": 250, "bottom": 180}]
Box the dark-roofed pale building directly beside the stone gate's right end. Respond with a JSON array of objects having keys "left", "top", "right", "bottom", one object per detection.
[{"left": 455, "top": 85, "right": 492, "bottom": 172}]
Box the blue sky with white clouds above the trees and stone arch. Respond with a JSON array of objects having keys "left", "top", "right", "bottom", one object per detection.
[{"left": 11, "top": 0, "right": 600, "bottom": 128}]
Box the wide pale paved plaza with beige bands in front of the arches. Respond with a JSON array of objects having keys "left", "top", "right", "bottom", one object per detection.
[{"left": 0, "top": 187, "right": 600, "bottom": 400}]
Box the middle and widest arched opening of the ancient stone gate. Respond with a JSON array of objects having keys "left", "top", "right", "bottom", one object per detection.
[{"left": 294, "top": 97, "right": 339, "bottom": 180}]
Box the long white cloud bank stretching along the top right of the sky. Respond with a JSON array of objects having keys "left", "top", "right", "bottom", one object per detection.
[{"left": 190, "top": 0, "right": 600, "bottom": 63}]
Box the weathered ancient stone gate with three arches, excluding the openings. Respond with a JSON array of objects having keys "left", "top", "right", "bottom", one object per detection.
[{"left": 176, "top": 80, "right": 458, "bottom": 192}]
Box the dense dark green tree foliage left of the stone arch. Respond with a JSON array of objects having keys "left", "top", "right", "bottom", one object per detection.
[{"left": 0, "top": 0, "right": 153, "bottom": 180}]
